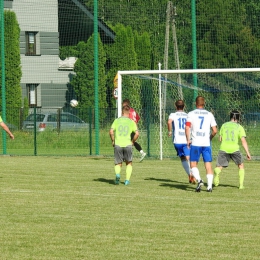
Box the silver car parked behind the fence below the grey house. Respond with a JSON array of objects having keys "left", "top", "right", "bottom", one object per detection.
[{"left": 23, "top": 112, "right": 89, "bottom": 132}]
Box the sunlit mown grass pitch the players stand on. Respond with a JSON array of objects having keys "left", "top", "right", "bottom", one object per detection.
[{"left": 0, "top": 156, "right": 260, "bottom": 260}]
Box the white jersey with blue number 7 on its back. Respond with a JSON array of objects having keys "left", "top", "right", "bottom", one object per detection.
[{"left": 187, "top": 109, "right": 217, "bottom": 146}]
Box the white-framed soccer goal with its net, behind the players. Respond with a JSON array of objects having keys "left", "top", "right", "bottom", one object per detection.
[{"left": 117, "top": 68, "right": 260, "bottom": 160}]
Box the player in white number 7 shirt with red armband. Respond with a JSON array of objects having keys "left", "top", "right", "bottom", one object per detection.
[{"left": 185, "top": 96, "right": 217, "bottom": 192}]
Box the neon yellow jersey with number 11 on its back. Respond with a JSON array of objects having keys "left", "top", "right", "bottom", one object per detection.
[{"left": 219, "top": 122, "right": 246, "bottom": 153}]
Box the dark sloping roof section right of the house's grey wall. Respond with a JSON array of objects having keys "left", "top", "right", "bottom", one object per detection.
[{"left": 58, "top": 0, "right": 115, "bottom": 46}]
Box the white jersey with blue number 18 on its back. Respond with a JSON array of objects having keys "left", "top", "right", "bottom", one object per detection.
[{"left": 169, "top": 112, "right": 188, "bottom": 144}]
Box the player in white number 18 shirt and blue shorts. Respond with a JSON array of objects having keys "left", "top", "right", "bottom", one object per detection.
[{"left": 168, "top": 99, "right": 196, "bottom": 184}]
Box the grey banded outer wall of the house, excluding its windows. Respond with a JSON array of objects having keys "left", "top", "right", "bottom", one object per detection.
[{"left": 12, "top": 0, "right": 74, "bottom": 108}]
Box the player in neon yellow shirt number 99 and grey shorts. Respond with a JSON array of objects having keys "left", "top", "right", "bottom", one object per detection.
[{"left": 109, "top": 105, "right": 139, "bottom": 185}]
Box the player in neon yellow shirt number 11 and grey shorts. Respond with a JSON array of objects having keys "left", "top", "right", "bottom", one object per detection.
[{"left": 213, "top": 110, "right": 251, "bottom": 189}]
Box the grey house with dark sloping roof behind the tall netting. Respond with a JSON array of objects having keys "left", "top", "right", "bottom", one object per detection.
[{"left": 4, "top": 0, "right": 115, "bottom": 109}]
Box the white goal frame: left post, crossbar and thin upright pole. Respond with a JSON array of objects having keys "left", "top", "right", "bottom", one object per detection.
[{"left": 117, "top": 68, "right": 260, "bottom": 160}]
